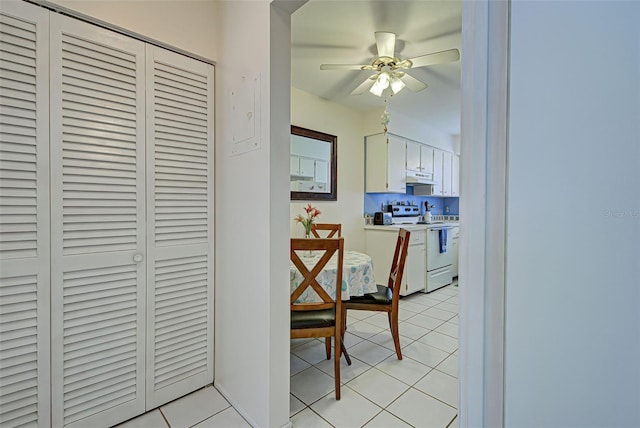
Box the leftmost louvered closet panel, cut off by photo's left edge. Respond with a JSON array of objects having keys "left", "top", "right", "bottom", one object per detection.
[{"left": 0, "top": 2, "right": 51, "bottom": 427}]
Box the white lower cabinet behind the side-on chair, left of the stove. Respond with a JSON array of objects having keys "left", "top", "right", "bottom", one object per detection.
[{"left": 365, "top": 227, "right": 427, "bottom": 296}]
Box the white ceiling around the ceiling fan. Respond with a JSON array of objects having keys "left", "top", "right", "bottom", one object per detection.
[{"left": 291, "top": 0, "right": 462, "bottom": 135}]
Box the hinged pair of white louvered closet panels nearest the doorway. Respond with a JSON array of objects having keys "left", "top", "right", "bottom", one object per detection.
[{"left": 51, "top": 10, "right": 213, "bottom": 427}]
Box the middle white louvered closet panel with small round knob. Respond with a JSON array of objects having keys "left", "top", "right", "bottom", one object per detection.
[{"left": 51, "top": 15, "right": 146, "bottom": 427}]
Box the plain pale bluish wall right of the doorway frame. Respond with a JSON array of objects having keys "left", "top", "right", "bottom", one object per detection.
[{"left": 505, "top": 1, "right": 640, "bottom": 427}]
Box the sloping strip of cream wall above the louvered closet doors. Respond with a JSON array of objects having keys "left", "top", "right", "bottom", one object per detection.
[{"left": 49, "top": 0, "right": 217, "bottom": 60}]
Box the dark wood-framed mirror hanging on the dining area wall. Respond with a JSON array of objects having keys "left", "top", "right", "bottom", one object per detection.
[{"left": 289, "top": 125, "right": 338, "bottom": 201}]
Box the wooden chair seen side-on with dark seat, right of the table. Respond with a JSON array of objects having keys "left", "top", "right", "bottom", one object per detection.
[{"left": 342, "top": 229, "right": 411, "bottom": 360}]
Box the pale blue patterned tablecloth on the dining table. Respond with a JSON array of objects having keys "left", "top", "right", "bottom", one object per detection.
[{"left": 289, "top": 251, "right": 377, "bottom": 302}]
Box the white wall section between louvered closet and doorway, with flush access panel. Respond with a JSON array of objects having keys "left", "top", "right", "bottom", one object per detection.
[{"left": 215, "top": 1, "right": 290, "bottom": 427}]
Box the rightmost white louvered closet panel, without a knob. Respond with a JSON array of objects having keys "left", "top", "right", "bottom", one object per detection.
[{"left": 146, "top": 46, "right": 213, "bottom": 409}]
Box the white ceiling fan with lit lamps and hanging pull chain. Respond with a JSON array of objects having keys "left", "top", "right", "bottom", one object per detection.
[{"left": 320, "top": 31, "right": 460, "bottom": 97}]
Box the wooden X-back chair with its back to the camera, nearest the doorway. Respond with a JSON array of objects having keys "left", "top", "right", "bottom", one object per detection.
[{"left": 290, "top": 238, "right": 344, "bottom": 400}]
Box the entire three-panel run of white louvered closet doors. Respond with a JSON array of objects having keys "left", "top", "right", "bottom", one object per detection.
[{"left": 0, "top": 2, "right": 213, "bottom": 427}]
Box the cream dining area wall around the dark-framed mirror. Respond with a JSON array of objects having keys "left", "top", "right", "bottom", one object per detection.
[{"left": 289, "top": 88, "right": 365, "bottom": 251}]
